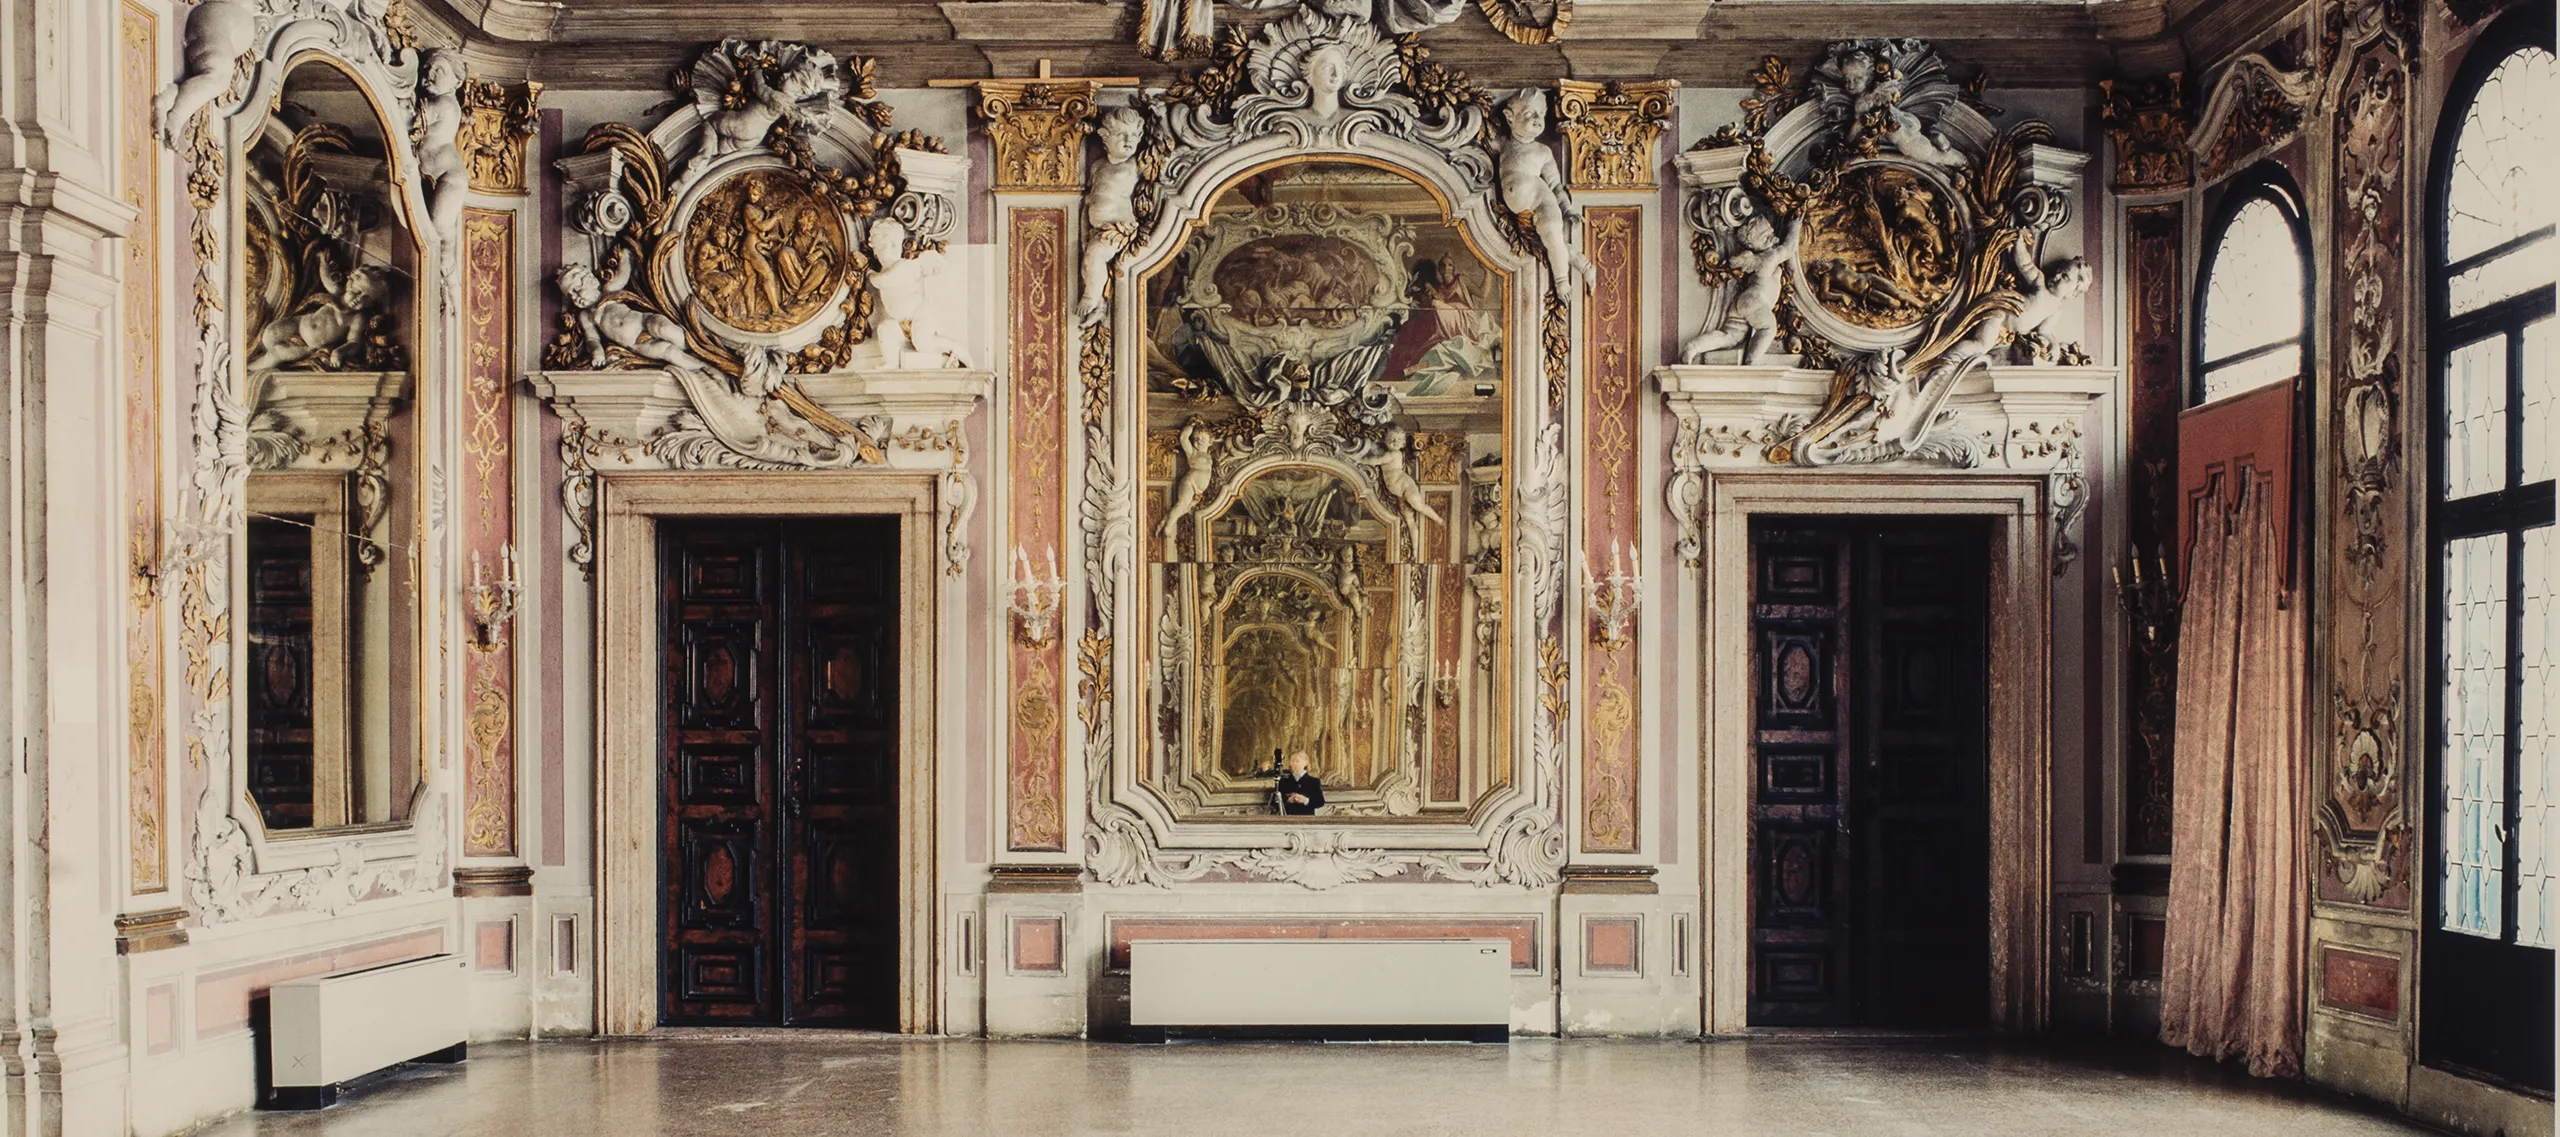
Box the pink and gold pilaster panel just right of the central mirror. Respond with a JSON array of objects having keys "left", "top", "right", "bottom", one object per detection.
[{"left": 1582, "top": 205, "right": 1644, "bottom": 853}]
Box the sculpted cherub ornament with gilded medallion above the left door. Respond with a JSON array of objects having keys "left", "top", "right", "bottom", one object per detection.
[{"left": 543, "top": 38, "right": 960, "bottom": 469}]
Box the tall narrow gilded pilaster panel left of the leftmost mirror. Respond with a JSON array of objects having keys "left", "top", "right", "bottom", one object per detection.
[{"left": 115, "top": 0, "right": 169, "bottom": 894}]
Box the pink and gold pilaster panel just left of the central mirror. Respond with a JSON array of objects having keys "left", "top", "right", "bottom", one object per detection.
[{"left": 998, "top": 208, "right": 1080, "bottom": 853}]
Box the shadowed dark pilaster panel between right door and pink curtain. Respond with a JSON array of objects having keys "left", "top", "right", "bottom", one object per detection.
[{"left": 2117, "top": 206, "right": 2186, "bottom": 855}]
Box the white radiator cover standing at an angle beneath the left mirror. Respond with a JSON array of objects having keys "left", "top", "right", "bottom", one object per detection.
[{"left": 266, "top": 955, "right": 471, "bottom": 1088}]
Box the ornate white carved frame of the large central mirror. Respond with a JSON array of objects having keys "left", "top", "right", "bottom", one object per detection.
[{"left": 1075, "top": 10, "right": 1569, "bottom": 889}]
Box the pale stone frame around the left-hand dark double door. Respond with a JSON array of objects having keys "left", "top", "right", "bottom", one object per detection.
[{"left": 596, "top": 471, "right": 942, "bottom": 1035}]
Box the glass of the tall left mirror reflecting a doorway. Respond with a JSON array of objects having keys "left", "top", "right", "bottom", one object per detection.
[{"left": 233, "top": 56, "right": 428, "bottom": 835}]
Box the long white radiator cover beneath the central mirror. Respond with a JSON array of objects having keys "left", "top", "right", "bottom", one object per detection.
[{"left": 1129, "top": 940, "right": 1510, "bottom": 1027}]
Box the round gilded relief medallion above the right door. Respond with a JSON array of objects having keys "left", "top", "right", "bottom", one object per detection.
[{"left": 1800, "top": 164, "right": 1961, "bottom": 330}]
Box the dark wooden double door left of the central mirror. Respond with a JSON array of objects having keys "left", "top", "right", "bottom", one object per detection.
[{"left": 658, "top": 517, "right": 899, "bottom": 1029}]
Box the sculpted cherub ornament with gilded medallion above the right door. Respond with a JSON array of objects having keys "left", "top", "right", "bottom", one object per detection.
[{"left": 1679, "top": 38, "right": 2089, "bottom": 468}]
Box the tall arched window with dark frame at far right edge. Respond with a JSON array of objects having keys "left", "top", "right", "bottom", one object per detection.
[{"left": 2419, "top": 10, "right": 2560, "bottom": 1091}]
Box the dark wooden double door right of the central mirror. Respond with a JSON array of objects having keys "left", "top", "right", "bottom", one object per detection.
[{"left": 1751, "top": 517, "right": 1989, "bottom": 1029}]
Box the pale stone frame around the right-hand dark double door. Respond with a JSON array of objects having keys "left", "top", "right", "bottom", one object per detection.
[{"left": 1697, "top": 471, "right": 2053, "bottom": 1035}]
